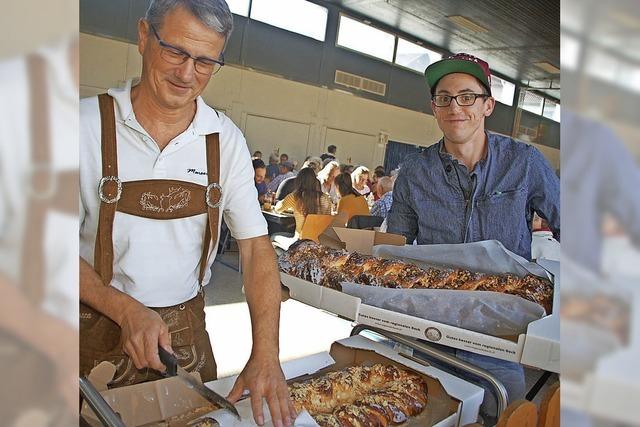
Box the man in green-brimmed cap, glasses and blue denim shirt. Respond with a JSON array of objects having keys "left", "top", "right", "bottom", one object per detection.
[{"left": 387, "top": 54, "right": 560, "bottom": 422}]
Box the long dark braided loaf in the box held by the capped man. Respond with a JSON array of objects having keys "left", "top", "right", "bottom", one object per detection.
[{"left": 278, "top": 240, "right": 553, "bottom": 313}]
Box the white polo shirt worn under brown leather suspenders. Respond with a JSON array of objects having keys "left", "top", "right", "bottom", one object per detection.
[{"left": 80, "top": 81, "right": 267, "bottom": 307}]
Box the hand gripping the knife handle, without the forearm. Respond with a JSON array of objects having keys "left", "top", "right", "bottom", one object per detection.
[{"left": 120, "top": 303, "right": 173, "bottom": 372}]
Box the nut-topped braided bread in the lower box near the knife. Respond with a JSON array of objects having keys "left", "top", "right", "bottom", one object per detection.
[{"left": 289, "top": 364, "right": 428, "bottom": 427}]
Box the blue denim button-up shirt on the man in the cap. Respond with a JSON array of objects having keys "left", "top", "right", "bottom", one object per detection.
[{"left": 387, "top": 133, "right": 560, "bottom": 259}]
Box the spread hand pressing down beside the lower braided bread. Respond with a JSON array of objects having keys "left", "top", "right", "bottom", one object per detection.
[{"left": 227, "top": 355, "right": 296, "bottom": 427}]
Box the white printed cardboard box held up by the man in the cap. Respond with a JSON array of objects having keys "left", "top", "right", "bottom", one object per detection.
[{"left": 280, "top": 263, "right": 560, "bottom": 372}]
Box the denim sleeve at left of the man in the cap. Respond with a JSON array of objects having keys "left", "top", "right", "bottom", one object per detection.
[{"left": 387, "top": 170, "right": 418, "bottom": 244}]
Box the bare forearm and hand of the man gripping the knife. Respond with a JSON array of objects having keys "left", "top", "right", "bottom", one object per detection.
[{"left": 80, "top": 257, "right": 173, "bottom": 372}]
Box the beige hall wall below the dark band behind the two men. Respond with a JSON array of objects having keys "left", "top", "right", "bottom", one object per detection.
[{"left": 80, "top": 34, "right": 560, "bottom": 168}]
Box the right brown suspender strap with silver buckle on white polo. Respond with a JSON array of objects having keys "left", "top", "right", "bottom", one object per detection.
[{"left": 198, "top": 133, "right": 222, "bottom": 286}]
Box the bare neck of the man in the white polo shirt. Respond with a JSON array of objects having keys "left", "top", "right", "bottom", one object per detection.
[{"left": 131, "top": 82, "right": 196, "bottom": 150}]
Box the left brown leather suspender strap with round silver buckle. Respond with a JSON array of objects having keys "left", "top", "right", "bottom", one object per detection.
[{"left": 93, "top": 93, "right": 122, "bottom": 285}]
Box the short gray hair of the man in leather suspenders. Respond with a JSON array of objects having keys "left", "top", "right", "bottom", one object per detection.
[{"left": 144, "top": 0, "right": 233, "bottom": 40}]
